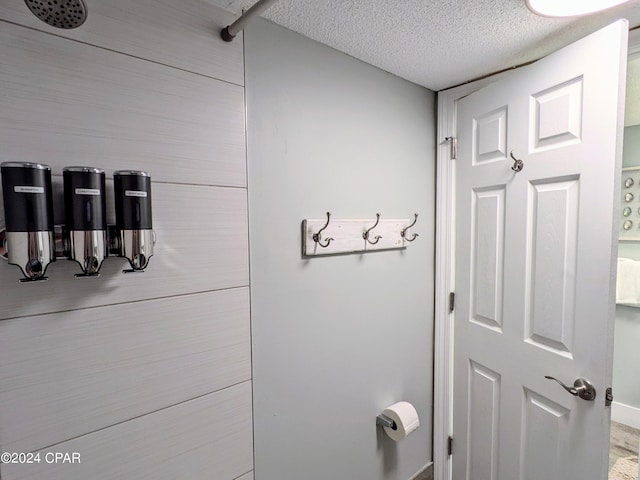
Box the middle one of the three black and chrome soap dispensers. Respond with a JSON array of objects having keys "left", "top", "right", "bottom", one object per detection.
[{"left": 62, "top": 167, "right": 108, "bottom": 277}]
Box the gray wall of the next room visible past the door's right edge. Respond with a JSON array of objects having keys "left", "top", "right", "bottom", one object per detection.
[{"left": 613, "top": 125, "right": 640, "bottom": 408}]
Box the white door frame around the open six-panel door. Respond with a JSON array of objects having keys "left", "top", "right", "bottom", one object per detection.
[{"left": 433, "top": 25, "right": 640, "bottom": 480}]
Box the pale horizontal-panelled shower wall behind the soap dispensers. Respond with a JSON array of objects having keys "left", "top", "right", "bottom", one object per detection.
[{"left": 0, "top": 0, "right": 253, "bottom": 480}]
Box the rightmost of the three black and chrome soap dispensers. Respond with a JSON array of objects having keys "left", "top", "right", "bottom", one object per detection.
[{"left": 113, "top": 170, "right": 155, "bottom": 272}]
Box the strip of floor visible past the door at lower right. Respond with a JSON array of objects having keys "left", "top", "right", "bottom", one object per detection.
[{"left": 609, "top": 422, "right": 640, "bottom": 480}]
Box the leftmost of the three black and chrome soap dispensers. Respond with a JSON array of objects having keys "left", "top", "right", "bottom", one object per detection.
[{"left": 0, "top": 162, "right": 56, "bottom": 282}]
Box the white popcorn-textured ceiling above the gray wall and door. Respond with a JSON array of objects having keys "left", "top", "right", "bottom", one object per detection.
[{"left": 207, "top": 0, "right": 640, "bottom": 90}]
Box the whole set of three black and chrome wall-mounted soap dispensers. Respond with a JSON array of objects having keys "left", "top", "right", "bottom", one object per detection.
[{"left": 0, "top": 167, "right": 156, "bottom": 282}]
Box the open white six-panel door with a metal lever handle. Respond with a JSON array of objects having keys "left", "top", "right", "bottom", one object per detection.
[{"left": 453, "top": 21, "right": 628, "bottom": 480}]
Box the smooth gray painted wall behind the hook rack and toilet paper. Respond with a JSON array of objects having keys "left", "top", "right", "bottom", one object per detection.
[{"left": 245, "top": 20, "right": 435, "bottom": 480}]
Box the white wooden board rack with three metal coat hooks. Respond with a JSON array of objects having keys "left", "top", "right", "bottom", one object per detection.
[{"left": 302, "top": 212, "right": 418, "bottom": 257}]
